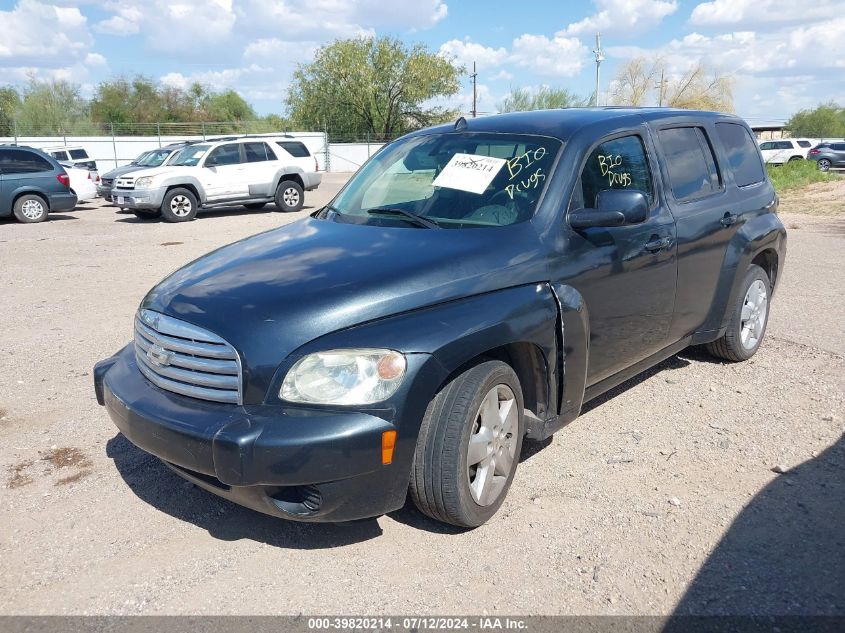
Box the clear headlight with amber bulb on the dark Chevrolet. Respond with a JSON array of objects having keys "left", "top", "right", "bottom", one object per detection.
[{"left": 279, "top": 349, "right": 407, "bottom": 404}]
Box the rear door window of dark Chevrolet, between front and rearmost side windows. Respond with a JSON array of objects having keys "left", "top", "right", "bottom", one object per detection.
[{"left": 658, "top": 127, "right": 722, "bottom": 201}]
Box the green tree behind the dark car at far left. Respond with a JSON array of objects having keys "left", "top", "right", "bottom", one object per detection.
[{"left": 17, "top": 79, "right": 95, "bottom": 135}]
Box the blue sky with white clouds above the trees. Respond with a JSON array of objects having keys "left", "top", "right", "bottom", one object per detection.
[{"left": 0, "top": 0, "right": 845, "bottom": 123}]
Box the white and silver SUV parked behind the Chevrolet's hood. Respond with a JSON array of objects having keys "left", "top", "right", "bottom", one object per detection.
[{"left": 112, "top": 136, "right": 321, "bottom": 222}]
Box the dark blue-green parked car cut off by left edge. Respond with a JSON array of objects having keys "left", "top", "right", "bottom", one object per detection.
[{"left": 0, "top": 145, "right": 77, "bottom": 223}]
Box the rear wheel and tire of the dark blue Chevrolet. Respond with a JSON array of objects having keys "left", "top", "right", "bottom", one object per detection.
[{"left": 707, "top": 265, "right": 772, "bottom": 362}]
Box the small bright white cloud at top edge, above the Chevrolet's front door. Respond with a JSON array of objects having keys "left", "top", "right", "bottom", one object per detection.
[{"left": 560, "top": 0, "right": 676, "bottom": 36}]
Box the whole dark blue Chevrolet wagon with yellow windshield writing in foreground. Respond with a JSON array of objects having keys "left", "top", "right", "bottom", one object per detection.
[{"left": 94, "top": 108, "right": 786, "bottom": 527}]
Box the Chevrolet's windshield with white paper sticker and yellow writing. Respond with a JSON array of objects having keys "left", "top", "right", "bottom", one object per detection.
[{"left": 331, "top": 132, "right": 561, "bottom": 229}]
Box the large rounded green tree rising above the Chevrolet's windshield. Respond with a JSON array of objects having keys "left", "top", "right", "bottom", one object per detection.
[{"left": 286, "top": 37, "right": 463, "bottom": 136}]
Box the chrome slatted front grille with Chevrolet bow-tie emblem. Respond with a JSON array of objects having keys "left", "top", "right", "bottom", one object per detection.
[{"left": 135, "top": 310, "right": 241, "bottom": 404}]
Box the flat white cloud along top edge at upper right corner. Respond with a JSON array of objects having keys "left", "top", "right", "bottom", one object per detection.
[{"left": 689, "top": 0, "right": 842, "bottom": 30}]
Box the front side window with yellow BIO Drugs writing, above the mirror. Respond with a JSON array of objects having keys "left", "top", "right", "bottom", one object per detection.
[{"left": 569, "top": 134, "right": 654, "bottom": 209}]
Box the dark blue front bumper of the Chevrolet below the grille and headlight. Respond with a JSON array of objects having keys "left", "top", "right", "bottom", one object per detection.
[{"left": 94, "top": 345, "right": 410, "bottom": 521}]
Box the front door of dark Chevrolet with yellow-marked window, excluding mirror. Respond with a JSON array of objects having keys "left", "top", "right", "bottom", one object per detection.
[{"left": 553, "top": 127, "right": 677, "bottom": 386}]
